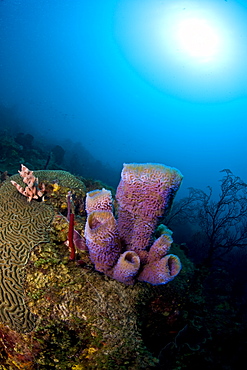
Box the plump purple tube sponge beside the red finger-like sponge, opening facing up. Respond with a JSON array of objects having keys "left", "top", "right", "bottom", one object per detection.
[{"left": 85, "top": 211, "right": 121, "bottom": 275}]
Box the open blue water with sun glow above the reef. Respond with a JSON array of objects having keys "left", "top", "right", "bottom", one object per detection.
[{"left": 0, "top": 0, "right": 247, "bottom": 196}]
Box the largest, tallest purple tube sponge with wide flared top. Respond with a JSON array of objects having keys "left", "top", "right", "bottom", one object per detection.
[{"left": 116, "top": 163, "right": 183, "bottom": 263}]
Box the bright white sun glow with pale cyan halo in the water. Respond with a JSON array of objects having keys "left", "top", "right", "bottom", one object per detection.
[{"left": 116, "top": 0, "right": 247, "bottom": 102}]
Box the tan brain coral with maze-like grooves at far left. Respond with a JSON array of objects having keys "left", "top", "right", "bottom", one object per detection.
[{"left": 0, "top": 171, "right": 85, "bottom": 332}]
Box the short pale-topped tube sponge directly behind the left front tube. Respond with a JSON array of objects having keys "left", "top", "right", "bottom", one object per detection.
[{"left": 86, "top": 188, "right": 112, "bottom": 214}]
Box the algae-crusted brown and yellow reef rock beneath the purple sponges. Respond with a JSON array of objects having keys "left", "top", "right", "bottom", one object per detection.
[{"left": 0, "top": 221, "right": 193, "bottom": 370}]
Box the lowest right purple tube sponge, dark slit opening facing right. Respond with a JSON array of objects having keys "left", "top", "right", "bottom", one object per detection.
[{"left": 138, "top": 254, "right": 181, "bottom": 285}]
